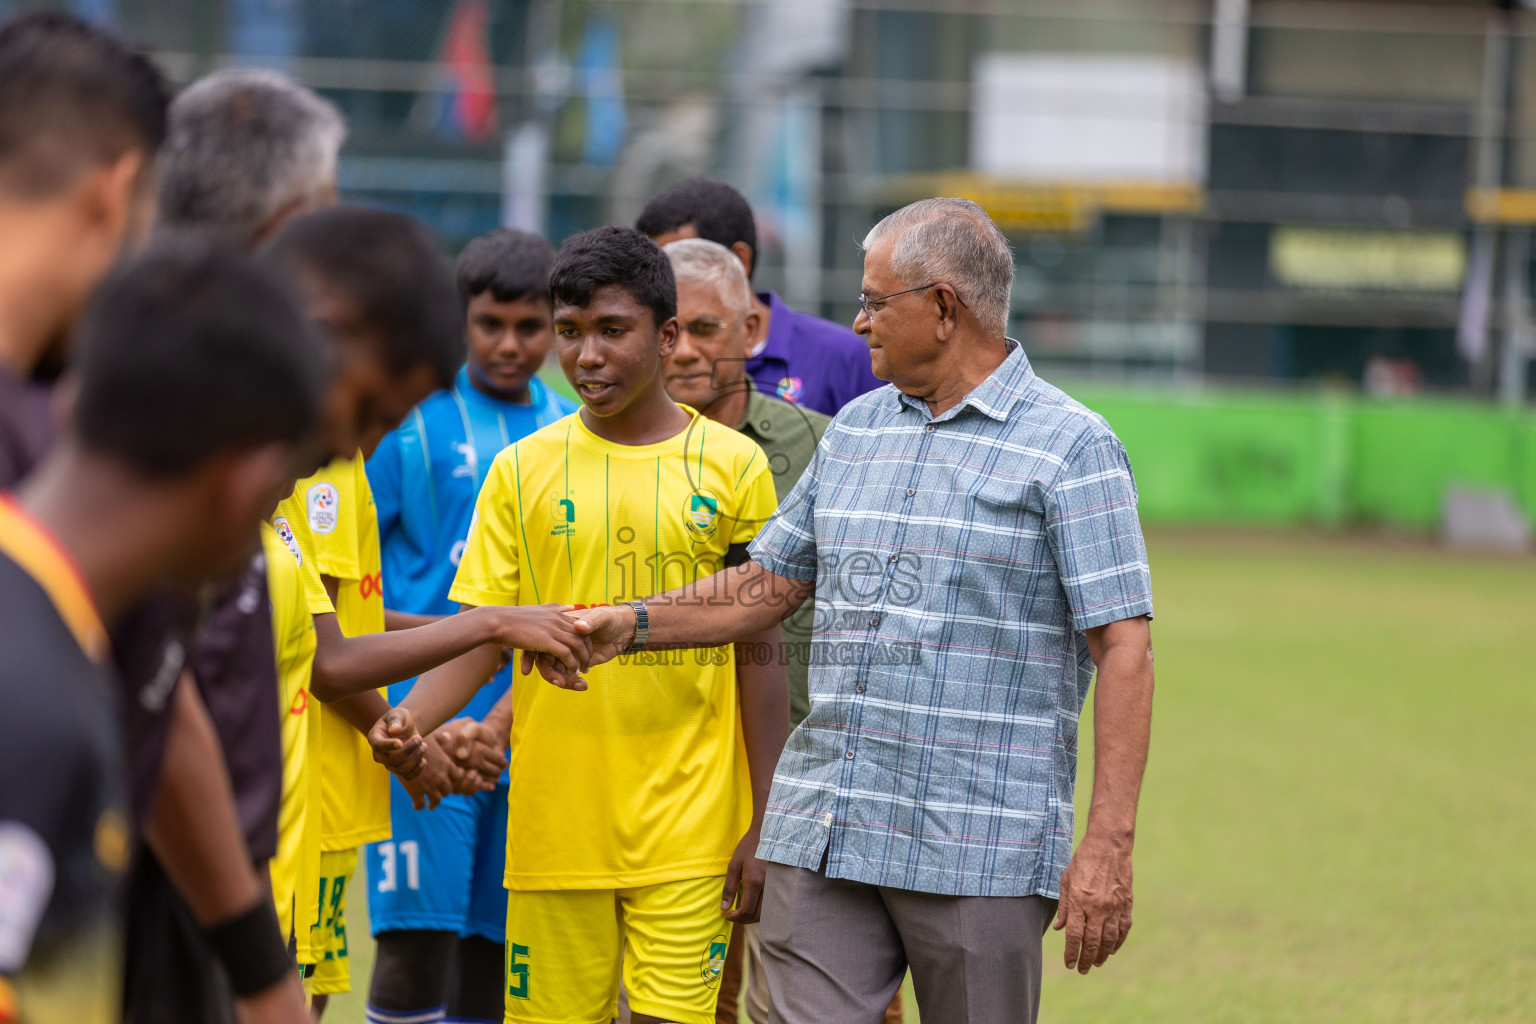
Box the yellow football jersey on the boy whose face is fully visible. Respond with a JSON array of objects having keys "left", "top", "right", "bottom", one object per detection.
[{"left": 450, "top": 410, "right": 776, "bottom": 889}]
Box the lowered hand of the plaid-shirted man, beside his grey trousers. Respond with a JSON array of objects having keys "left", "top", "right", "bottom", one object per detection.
[{"left": 1054, "top": 834, "right": 1132, "bottom": 975}]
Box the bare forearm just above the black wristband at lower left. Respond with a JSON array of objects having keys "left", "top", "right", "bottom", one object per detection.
[{"left": 144, "top": 672, "right": 266, "bottom": 927}]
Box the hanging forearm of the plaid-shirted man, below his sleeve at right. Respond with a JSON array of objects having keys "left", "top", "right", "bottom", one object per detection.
[{"left": 1087, "top": 619, "right": 1154, "bottom": 847}]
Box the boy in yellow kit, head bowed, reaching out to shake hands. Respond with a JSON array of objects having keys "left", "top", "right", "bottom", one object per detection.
[{"left": 263, "top": 207, "right": 584, "bottom": 1012}]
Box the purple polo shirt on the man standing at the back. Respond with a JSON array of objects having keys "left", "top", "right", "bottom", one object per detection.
[{"left": 746, "top": 292, "right": 885, "bottom": 416}]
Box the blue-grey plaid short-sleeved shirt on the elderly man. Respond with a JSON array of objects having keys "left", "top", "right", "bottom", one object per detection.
[{"left": 751, "top": 342, "right": 1152, "bottom": 897}]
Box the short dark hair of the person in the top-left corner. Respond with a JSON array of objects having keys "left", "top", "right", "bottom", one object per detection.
[{"left": 0, "top": 12, "right": 170, "bottom": 197}]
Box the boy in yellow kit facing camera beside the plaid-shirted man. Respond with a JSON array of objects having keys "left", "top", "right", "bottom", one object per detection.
[{"left": 370, "top": 227, "right": 790, "bottom": 1024}]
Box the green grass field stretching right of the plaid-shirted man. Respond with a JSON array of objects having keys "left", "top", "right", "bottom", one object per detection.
[{"left": 327, "top": 531, "right": 1536, "bottom": 1024}]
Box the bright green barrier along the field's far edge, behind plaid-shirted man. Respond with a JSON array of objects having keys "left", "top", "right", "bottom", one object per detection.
[{"left": 1066, "top": 384, "right": 1536, "bottom": 530}]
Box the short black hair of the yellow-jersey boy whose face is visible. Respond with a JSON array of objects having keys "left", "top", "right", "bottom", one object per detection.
[{"left": 550, "top": 227, "right": 677, "bottom": 327}]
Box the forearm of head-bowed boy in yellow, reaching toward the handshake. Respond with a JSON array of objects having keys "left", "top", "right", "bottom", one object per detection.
[{"left": 310, "top": 616, "right": 496, "bottom": 702}]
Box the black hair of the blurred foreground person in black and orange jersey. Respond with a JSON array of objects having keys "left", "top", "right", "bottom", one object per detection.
[{"left": 74, "top": 233, "right": 327, "bottom": 477}]
